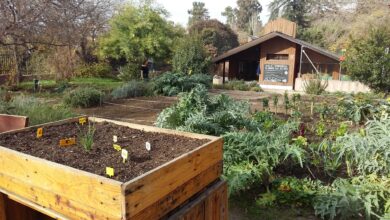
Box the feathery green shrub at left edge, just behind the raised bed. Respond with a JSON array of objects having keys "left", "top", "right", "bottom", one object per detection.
[{"left": 0, "top": 96, "right": 75, "bottom": 126}]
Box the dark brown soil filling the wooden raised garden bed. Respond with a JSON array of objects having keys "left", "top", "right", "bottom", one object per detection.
[{"left": 0, "top": 122, "right": 209, "bottom": 182}]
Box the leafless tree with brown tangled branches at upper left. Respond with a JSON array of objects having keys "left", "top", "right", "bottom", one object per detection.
[{"left": 0, "top": 0, "right": 116, "bottom": 82}]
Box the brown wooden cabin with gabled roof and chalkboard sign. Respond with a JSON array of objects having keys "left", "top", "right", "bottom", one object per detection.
[{"left": 213, "top": 19, "right": 341, "bottom": 90}]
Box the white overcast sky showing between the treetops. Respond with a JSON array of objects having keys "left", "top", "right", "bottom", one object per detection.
[{"left": 157, "top": 0, "right": 271, "bottom": 26}]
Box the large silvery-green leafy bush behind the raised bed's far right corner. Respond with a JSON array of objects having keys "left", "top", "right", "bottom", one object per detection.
[{"left": 156, "top": 85, "right": 256, "bottom": 135}]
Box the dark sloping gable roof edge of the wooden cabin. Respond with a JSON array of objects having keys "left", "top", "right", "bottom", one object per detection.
[{"left": 212, "top": 32, "right": 340, "bottom": 63}]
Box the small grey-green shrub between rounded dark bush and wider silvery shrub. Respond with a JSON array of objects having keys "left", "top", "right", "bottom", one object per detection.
[{"left": 111, "top": 80, "right": 153, "bottom": 99}]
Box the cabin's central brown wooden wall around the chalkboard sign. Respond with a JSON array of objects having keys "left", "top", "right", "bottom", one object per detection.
[{"left": 260, "top": 37, "right": 296, "bottom": 86}]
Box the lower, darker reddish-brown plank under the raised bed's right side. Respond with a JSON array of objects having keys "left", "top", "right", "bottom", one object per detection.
[{"left": 131, "top": 161, "right": 223, "bottom": 220}]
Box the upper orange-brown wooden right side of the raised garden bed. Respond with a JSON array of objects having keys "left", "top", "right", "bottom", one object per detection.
[{"left": 124, "top": 138, "right": 223, "bottom": 217}]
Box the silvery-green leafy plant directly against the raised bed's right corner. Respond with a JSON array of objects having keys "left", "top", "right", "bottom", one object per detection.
[{"left": 223, "top": 121, "right": 305, "bottom": 194}]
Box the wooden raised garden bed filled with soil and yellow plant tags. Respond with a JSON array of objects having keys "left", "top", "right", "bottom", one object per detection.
[{"left": 0, "top": 117, "right": 223, "bottom": 219}]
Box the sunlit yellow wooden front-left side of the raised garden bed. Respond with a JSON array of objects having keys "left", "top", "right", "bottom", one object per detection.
[{"left": 0, "top": 147, "right": 122, "bottom": 219}]
